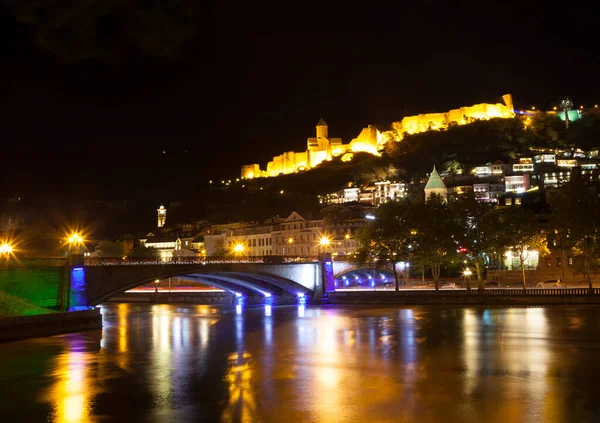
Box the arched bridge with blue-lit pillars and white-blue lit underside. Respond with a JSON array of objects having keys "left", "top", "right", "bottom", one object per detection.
[{"left": 70, "top": 256, "right": 334, "bottom": 308}]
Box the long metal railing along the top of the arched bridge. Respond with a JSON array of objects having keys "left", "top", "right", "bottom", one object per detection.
[{"left": 84, "top": 256, "right": 319, "bottom": 266}]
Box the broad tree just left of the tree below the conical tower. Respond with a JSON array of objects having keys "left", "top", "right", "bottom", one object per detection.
[{"left": 356, "top": 202, "right": 412, "bottom": 291}]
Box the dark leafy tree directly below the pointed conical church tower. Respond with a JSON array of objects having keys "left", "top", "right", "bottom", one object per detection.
[{"left": 410, "top": 194, "right": 457, "bottom": 290}]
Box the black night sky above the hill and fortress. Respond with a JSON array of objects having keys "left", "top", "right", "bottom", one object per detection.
[{"left": 0, "top": 0, "right": 600, "bottom": 200}]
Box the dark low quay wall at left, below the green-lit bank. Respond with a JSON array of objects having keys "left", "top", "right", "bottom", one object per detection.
[{"left": 0, "top": 308, "right": 102, "bottom": 342}]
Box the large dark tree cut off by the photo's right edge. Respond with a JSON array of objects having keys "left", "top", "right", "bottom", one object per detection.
[{"left": 548, "top": 178, "right": 600, "bottom": 293}]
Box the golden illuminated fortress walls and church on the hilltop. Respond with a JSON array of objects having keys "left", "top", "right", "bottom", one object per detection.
[{"left": 242, "top": 94, "right": 515, "bottom": 179}]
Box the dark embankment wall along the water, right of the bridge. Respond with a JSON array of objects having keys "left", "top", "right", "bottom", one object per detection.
[{"left": 327, "top": 288, "right": 600, "bottom": 305}]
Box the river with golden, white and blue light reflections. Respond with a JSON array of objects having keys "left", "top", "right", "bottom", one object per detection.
[{"left": 0, "top": 304, "right": 600, "bottom": 423}]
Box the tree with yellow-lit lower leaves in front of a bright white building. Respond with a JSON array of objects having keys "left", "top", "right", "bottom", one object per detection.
[{"left": 501, "top": 206, "right": 550, "bottom": 289}]
